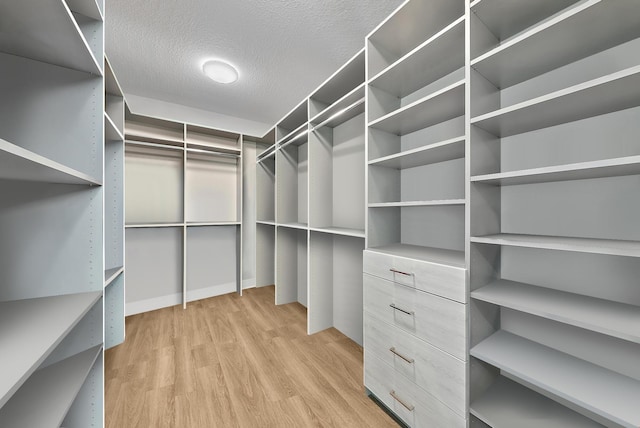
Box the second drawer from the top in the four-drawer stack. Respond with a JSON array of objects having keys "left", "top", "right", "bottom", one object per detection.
[{"left": 363, "top": 274, "right": 467, "bottom": 361}]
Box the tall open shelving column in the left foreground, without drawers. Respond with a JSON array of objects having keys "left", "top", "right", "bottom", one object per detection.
[{"left": 0, "top": 0, "right": 104, "bottom": 427}]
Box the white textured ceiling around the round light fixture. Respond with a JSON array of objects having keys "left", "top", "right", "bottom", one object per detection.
[{"left": 106, "top": 0, "right": 402, "bottom": 135}]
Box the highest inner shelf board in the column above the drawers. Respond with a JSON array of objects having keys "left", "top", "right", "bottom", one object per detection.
[{"left": 369, "top": 16, "right": 465, "bottom": 98}]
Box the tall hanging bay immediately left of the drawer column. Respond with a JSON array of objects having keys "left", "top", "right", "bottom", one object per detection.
[{"left": 308, "top": 49, "right": 365, "bottom": 345}]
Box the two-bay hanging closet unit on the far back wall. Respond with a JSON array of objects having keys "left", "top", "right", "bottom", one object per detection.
[{"left": 125, "top": 112, "right": 242, "bottom": 314}]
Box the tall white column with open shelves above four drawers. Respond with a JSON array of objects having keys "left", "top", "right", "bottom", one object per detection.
[{"left": 363, "top": 0, "right": 468, "bottom": 427}]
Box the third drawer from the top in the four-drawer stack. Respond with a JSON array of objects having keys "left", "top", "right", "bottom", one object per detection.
[{"left": 364, "top": 313, "right": 467, "bottom": 416}]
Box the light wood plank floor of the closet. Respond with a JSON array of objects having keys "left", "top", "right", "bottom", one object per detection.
[{"left": 105, "top": 287, "right": 397, "bottom": 428}]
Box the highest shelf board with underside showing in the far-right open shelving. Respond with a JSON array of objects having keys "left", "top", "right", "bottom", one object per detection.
[{"left": 471, "top": 0, "right": 640, "bottom": 89}]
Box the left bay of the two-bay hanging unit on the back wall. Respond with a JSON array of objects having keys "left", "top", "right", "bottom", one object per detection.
[{"left": 125, "top": 109, "right": 185, "bottom": 315}]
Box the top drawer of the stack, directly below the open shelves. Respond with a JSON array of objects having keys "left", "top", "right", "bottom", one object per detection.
[{"left": 362, "top": 250, "right": 467, "bottom": 303}]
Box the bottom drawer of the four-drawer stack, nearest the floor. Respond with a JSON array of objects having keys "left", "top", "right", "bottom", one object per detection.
[{"left": 364, "top": 351, "right": 466, "bottom": 428}]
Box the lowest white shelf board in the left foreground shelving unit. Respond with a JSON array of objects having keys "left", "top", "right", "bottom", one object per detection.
[{"left": 0, "top": 346, "right": 102, "bottom": 428}]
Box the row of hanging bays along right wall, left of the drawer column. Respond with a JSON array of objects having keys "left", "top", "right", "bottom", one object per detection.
[{"left": 256, "top": 50, "right": 365, "bottom": 343}]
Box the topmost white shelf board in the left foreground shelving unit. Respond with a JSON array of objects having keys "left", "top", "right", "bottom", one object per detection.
[{"left": 0, "top": 0, "right": 102, "bottom": 76}]
